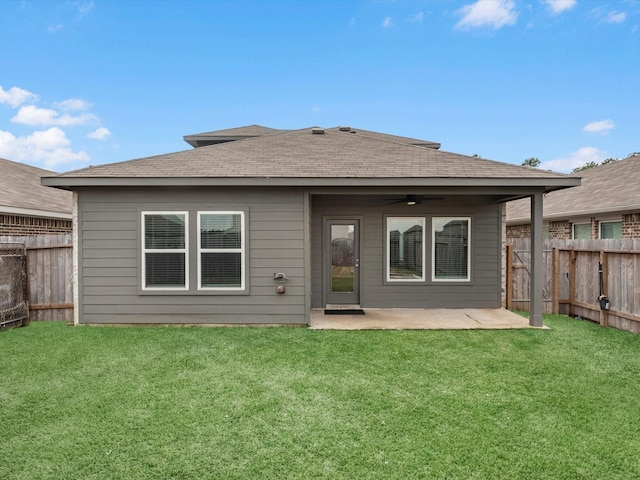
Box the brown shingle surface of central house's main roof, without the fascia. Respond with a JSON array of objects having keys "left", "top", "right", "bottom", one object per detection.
[{"left": 50, "top": 127, "right": 565, "bottom": 179}]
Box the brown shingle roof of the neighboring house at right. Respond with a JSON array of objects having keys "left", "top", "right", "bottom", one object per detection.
[{"left": 507, "top": 155, "right": 640, "bottom": 225}]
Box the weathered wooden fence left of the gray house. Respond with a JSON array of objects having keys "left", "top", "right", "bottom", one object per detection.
[{"left": 0, "top": 234, "right": 73, "bottom": 321}]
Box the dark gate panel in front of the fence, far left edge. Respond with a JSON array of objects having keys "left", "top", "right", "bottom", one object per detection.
[{"left": 0, "top": 243, "right": 29, "bottom": 329}]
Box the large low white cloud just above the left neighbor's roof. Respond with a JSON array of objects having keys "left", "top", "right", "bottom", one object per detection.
[{"left": 0, "top": 127, "right": 89, "bottom": 170}]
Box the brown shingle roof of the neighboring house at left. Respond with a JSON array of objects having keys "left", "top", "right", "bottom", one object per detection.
[{"left": 0, "top": 158, "right": 73, "bottom": 219}]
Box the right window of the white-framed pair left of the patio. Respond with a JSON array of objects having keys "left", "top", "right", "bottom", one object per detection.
[{"left": 198, "top": 211, "right": 245, "bottom": 290}]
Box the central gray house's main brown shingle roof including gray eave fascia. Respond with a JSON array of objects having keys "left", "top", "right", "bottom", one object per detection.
[{"left": 43, "top": 127, "right": 579, "bottom": 197}]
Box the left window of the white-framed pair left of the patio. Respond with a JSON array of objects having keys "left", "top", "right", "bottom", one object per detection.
[{"left": 142, "top": 212, "right": 189, "bottom": 290}]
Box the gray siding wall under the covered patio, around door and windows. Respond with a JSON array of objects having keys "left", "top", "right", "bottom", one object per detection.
[{"left": 311, "top": 195, "right": 501, "bottom": 308}]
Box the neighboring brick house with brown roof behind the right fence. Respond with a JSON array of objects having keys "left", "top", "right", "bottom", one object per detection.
[{"left": 507, "top": 155, "right": 640, "bottom": 239}]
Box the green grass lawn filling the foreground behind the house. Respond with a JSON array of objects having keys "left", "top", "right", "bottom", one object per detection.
[{"left": 0, "top": 316, "right": 640, "bottom": 480}]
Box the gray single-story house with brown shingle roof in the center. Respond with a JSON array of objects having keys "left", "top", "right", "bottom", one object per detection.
[{"left": 43, "top": 126, "right": 580, "bottom": 326}]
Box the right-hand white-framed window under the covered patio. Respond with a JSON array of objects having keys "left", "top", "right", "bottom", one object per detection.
[{"left": 432, "top": 217, "right": 471, "bottom": 281}]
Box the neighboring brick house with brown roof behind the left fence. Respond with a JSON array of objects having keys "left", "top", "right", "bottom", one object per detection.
[{"left": 0, "top": 158, "right": 73, "bottom": 236}]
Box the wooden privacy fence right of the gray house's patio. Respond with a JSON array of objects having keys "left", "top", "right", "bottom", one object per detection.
[{"left": 506, "top": 238, "right": 640, "bottom": 333}]
